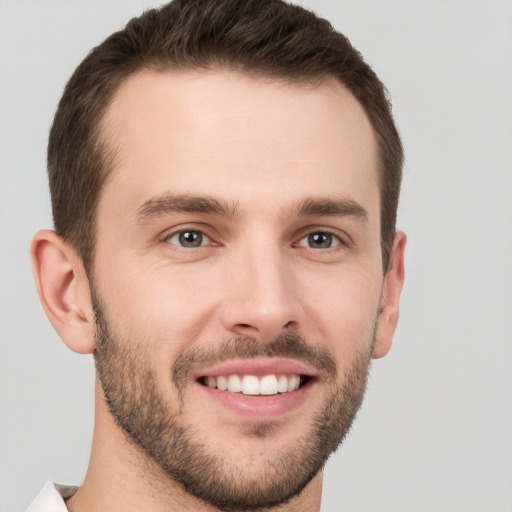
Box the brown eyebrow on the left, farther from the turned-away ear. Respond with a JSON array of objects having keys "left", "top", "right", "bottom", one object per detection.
[{"left": 136, "top": 194, "right": 237, "bottom": 224}]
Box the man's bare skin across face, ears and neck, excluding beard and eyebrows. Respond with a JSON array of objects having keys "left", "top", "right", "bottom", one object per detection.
[{"left": 32, "top": 70, "right": 405, "bottom": 512}]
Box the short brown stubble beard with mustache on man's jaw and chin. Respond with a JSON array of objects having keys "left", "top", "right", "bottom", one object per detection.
[{"left": 93, "top": 293, "right": 373, "bottom": 511}]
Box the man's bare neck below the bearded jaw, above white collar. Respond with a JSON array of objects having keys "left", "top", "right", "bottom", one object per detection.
[{"left": 66, "top": 384, "right": 322, "bottom": 512}]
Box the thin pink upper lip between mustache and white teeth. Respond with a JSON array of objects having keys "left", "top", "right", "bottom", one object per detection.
[{"left": 192, "top": 357, "right": 318, "bottom": 380}]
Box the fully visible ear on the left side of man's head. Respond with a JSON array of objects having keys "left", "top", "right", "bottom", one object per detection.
[{"left": 30, "top": 230, "right": 94, "bottom": 354}]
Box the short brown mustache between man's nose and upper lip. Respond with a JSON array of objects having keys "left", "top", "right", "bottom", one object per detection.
[{"left": 172, "top": 333, "right": 336, "bottom": 389}]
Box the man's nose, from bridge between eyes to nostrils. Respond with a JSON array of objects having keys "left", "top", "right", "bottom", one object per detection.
[{"left": 221, "top": 243, "right": 303, "bottom": 342}]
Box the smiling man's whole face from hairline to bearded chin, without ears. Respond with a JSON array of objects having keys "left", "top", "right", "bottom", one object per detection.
[{"left": 93, "top": 71, "right": 383, "bottom": 509}]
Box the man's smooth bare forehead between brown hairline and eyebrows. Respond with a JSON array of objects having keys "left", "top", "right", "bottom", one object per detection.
[{"left": 100, "top": 67, "right": 379, "bottom": 216}]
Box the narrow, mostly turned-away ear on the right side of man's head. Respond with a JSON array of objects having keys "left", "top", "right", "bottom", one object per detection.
[{"left": 373, "top": 232, "right": 407, "bottom": 359}]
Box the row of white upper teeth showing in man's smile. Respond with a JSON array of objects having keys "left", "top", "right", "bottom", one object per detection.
[{"left": 204, "top": 374, "right": 300, "bottom": 395}]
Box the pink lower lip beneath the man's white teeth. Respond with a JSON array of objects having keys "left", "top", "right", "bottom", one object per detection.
[{"left": 196, "top": 379, "right": 314, "bottom": 418}]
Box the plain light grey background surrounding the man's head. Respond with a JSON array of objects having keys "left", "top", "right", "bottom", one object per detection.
[{"left": 0, "top": 0, "right": 512, "bottom": 512}]
